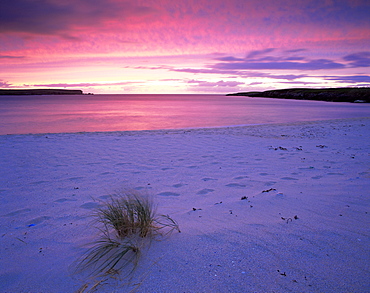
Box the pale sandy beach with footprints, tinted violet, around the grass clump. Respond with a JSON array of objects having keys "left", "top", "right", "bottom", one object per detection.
[{"left": 0, "top": 118, "right": 370, "bottom": 293}]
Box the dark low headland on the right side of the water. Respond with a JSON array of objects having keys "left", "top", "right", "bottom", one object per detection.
[{"left": 226, "top": 88, "right": 370, "bottom": 103}]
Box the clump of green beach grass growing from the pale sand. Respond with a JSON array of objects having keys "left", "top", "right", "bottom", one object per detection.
[{"left": 77, "top": 190, "right": 180, "bottom": 275}]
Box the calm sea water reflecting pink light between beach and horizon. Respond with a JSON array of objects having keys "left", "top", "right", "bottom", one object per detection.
[{"left": 0, "top": 95, "right": 370, "bottom": 134}]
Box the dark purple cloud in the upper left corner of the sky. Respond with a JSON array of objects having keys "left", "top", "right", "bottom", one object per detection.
[{"left": 0, "top": 0, "right": 156, "bottom": 40}]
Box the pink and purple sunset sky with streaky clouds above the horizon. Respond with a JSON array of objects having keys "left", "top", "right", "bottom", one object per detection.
[{"left": 0, "top": 0, "right": 370, "bottom": 94}]
